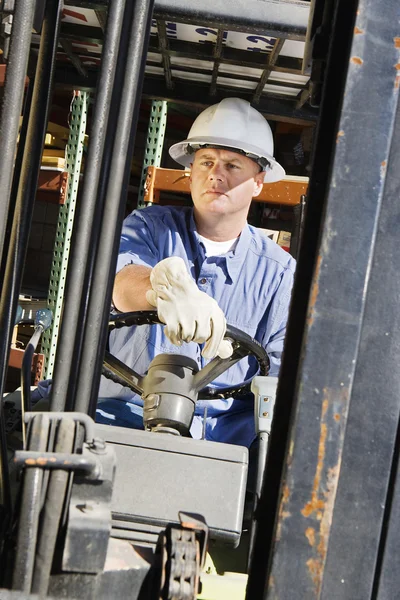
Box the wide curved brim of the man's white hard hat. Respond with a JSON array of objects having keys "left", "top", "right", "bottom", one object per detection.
[{"left": 169, "top": 137, "right": 286, "bottom": 183}]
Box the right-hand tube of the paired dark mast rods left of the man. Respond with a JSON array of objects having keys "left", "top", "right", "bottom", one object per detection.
[{"left": 74, "top": 0, "right": 154, "bottom": 416}]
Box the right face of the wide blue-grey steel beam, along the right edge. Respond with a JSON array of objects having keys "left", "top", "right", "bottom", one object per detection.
[{"left": 322, "top": 70, "right": 400, "bottom": 600}]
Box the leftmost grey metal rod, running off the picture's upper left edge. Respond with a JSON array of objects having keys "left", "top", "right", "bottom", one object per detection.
[{"left": 0, "top": 0, "right": 36, "bottom": 264}]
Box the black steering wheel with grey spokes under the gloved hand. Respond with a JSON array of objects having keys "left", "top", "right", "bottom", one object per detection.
[{"left": 103, "top": 311, "right": 270, "bottom": 400}]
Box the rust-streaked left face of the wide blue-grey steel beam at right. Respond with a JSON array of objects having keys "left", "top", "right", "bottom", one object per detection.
[{"left": 266, "top": 0, "right": 400, "bottom": 600}]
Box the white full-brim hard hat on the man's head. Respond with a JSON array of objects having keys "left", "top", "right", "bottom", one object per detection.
[{"left": 169, "top": 98, "right": 285, "bottom": 183}]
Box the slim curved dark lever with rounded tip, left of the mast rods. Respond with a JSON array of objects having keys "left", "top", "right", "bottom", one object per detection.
[{"left": 21, "top": 308, "right": 53, "bottom": 448}]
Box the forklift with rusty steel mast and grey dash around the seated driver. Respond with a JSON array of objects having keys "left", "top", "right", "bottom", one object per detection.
[{"left": 0, "top": 0, "right": 400, "bottom": 600}]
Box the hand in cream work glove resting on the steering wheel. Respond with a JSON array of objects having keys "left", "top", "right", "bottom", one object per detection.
[{"left": 146, "top": 256, "right": 232, "bottom": 358}]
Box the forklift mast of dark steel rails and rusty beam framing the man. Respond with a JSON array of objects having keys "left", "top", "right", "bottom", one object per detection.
[{"left": 0, "top": 0, "right": 400, "bottom": 600}]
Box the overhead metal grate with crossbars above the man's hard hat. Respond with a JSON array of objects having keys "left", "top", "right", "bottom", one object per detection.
[{"left": 27, "top": 0, "right": 317, "bottom": 123}]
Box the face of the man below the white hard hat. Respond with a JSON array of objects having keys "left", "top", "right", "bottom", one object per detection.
[{"left": 190, "top": 148, "right": 264, "bottom": 217}]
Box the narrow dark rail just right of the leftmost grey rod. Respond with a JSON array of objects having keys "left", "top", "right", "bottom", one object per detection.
[{"left": 0, "top": 1, "right": 62, "bottom": 528}]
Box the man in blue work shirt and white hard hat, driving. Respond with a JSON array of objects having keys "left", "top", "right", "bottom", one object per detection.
[{"left": 96, "top": 98, "right": 295, "bottom": 447}]
